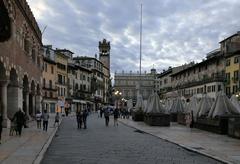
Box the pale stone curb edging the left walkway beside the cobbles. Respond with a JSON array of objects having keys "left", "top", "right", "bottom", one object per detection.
[{"left": 32, "top": 119, "right": 63, "bottom": 164}]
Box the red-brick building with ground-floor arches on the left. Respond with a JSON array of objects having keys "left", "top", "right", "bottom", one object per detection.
[{"left": 0, "top": 0, "right": 42, "bottom": 126}]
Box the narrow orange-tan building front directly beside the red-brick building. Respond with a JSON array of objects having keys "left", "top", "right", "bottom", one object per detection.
[{"left": 42, "top": 45, "right": 58, "bottom": 113}]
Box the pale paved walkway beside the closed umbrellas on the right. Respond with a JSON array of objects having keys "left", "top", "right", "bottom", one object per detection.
[{"left": 120, "top": 119, "right": 240, "bottom": 164}]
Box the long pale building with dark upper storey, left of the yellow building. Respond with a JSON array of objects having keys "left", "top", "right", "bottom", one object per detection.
[{"left": 167, "top": 49, "right": 225, "bottom": 98}]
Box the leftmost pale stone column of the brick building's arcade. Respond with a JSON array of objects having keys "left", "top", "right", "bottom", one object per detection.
[{"left": 0, "top": 80, "right": 10, "bottom": 128}]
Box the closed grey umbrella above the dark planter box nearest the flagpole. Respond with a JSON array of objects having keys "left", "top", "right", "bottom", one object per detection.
[{"left": 146, "top": 93, "right": 165, "bottom": 114}]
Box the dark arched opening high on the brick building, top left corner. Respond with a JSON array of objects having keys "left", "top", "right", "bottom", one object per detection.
[{"left": 0, "top": 0, "right": 11, "bottom": 42}]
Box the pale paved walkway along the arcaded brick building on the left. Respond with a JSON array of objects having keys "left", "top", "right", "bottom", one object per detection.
[{"left": 0, "top": 115, "right": 62, "bottom": 164}]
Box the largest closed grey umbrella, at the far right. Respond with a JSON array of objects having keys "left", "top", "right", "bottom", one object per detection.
[{"left": 208, "top": 92, "right": 240, "bottom": 118}]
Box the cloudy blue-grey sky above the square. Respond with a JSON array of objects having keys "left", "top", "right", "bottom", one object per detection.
[{"left": 27, "top": 0, "right": 240, "bottom": 73}]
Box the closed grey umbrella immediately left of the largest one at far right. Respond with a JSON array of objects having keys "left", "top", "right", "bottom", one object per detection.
[{"left": 197, "top": 94, "right": 212, "bottom": 117}]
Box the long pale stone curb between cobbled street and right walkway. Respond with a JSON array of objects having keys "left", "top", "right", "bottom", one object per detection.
[{"left": 119, "top": 120, "right": 234, "bottom": 164}]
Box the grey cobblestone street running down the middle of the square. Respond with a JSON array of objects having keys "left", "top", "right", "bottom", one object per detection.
[{"left": 42, "top": 115, "right": 223, "bottom": 164}]
